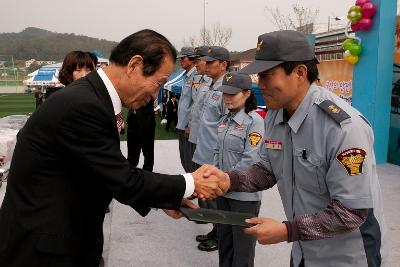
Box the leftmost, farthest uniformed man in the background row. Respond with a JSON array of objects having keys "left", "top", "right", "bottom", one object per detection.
[{"left": 176, "top": 47, "right": 196, "bottom": 174}]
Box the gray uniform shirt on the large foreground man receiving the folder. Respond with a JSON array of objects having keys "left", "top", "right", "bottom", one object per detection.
[{"left": 260, "top": 84, "right": 387, "bottom": 267}]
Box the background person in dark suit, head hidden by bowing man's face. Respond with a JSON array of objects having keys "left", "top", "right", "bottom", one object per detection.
[{"left": 127, "top": 101, "right": 156, "bottom": 171}]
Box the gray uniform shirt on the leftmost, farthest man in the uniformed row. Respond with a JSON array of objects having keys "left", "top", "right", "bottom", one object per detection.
[{"left": 176, "top": 67, "right": 196, "bottom": 130}]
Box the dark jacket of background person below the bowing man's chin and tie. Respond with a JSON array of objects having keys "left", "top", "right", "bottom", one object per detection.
[{"left": 127, "top": 101, "right": 156, "bottom": 129}]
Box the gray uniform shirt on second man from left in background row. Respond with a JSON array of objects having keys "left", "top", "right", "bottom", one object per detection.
[{"left": 189, "top": 75, "right": 212, "bottom": 144}]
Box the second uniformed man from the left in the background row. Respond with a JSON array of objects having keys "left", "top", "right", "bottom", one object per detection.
[{"left": 189, "top": 46, "right": 212, "bottom": 170}]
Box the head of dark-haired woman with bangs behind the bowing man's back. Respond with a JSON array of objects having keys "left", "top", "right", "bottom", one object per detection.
[{"left": 58, "top": 51, "right": 94, "bottom": 86}]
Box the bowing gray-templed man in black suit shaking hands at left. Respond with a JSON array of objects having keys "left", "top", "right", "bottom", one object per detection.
[{"left": 0, "top": 30, "right": 229, "bottom": 267}]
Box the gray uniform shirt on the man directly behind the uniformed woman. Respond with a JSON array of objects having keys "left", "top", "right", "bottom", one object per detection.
[{"left": 192, "top": 75, "right": 228, "bottom": 165}]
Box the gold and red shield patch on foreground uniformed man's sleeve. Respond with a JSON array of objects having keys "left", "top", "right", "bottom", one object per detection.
[{"left": 336, "top": 148, "right": 367, "bottom": 176}]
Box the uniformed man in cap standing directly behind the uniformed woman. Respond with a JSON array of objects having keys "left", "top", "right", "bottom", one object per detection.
[{"left": 192, "top": 46, "right": 230, "bottom": 251}]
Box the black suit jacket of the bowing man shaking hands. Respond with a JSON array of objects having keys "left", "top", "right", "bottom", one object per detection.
[{"left": 0, "top": 72, "right": 185, "bottom": 267}]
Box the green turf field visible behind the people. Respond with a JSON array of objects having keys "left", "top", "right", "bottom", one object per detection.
[{"left": 0, "top": 94, "right": 178, "bottom": 141}]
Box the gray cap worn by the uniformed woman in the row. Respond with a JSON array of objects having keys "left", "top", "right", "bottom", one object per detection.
[{"left": 219, "top": 72, "right": 251, "bottom": 95}]
